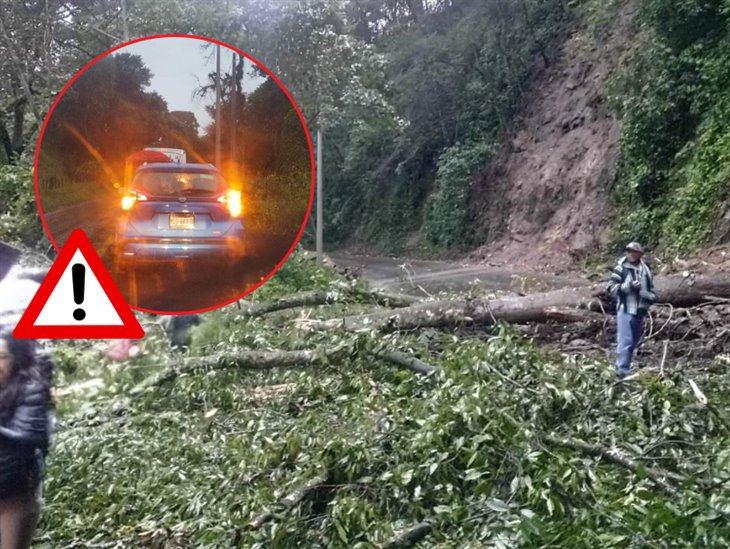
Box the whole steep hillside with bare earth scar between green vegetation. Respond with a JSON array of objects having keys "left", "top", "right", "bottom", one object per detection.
[{"left": 327, "top": 0, "right": 730, "bottom": 271}]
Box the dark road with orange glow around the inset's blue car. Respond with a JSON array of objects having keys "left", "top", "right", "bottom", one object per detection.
[{"left": 45, "top": 199, "right": 294, "bottom": 313}]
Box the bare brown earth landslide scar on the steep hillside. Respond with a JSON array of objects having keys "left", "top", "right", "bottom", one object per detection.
[{"left": 470, "top": 1, "right": 638, "bottom": 273}]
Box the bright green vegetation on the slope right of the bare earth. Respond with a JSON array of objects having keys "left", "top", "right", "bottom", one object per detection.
[{"left": 614, "top": 0, "right": 730, "bottom": 252}]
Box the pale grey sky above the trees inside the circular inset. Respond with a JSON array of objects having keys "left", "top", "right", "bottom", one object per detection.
[{"left": 118, "top": 37, "right": 264, "bottom": 134}]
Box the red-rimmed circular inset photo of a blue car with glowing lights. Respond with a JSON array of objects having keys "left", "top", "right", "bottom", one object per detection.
[{"left": 35, "top": 36, "right": 314, "bottom": 313}]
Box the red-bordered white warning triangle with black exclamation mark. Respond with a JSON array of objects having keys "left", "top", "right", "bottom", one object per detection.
[{"left": 13, "top": 229, "right": 144, "bottom": 339}]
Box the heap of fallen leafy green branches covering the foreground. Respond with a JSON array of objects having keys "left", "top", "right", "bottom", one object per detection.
[{"left": 41, "top": 264, "right": 730, "bottom": 548}]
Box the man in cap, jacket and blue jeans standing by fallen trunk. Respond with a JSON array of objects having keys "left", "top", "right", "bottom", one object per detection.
[{"left": 608, "top": 242, "right": 656, "bottom": 378}]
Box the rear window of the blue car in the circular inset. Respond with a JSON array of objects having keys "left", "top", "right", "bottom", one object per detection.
[{"left": 132, "top": 171, "right": 226, "bottom": 196}]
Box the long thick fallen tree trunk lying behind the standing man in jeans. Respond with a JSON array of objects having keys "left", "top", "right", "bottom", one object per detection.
[{"left": 303, "top": 274, "right": 730, "bottom": 332}]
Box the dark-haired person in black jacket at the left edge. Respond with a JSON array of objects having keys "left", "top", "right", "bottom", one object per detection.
[{"left": 0, "top": 329, "right": 52, "bottom": 549}]
